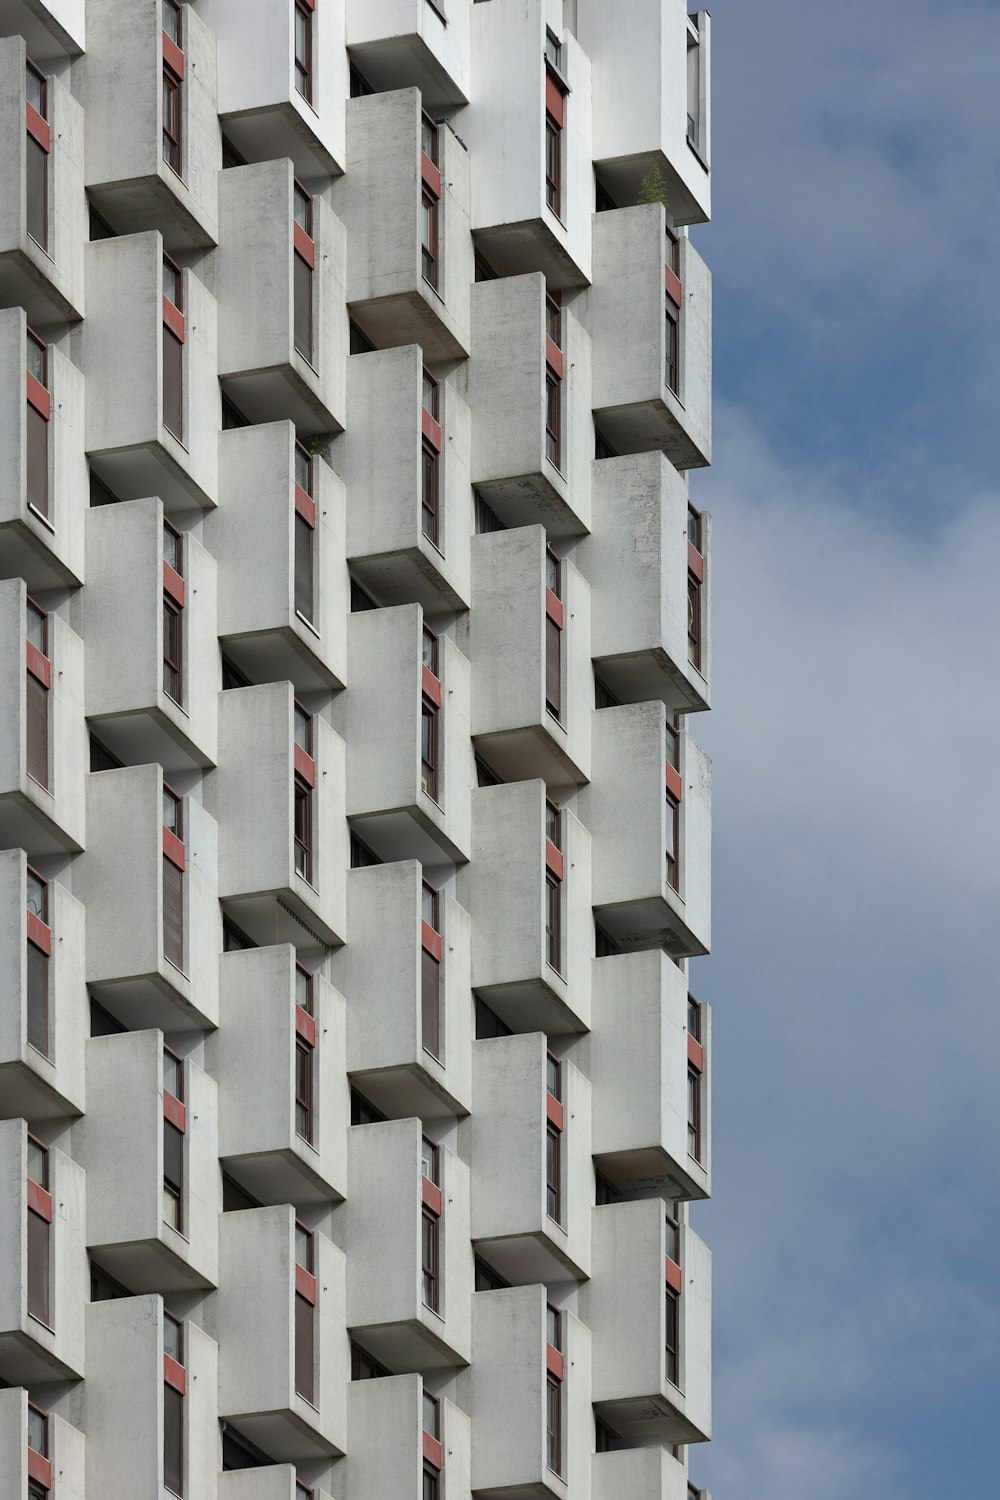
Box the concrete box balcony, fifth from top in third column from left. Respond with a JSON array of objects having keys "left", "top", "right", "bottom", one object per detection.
[{"left": 213, "top": 945, "right": 349, "bottom": 1206}]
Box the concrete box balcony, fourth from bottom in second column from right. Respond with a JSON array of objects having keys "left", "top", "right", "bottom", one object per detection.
[{"left": 469, "top": 527, "right": 594, "bottom": 786}]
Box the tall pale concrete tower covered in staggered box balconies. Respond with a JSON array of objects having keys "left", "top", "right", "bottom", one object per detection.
[{"left": 0, "top": 0, "right": 712, "bottom": 1500}]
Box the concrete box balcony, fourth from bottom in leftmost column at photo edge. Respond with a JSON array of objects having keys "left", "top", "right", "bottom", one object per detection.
[{"left": 0, "top": 578, "right": 85, "bottom": 860}]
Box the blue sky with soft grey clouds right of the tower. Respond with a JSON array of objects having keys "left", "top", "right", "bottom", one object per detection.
[{"left": 691, "top": 0, "right": 1000, "bottom": 1500}]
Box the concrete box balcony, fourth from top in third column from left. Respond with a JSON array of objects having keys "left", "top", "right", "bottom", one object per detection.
[{"left": 210, "top": 683, "right": 349, "bottom": 950}]
